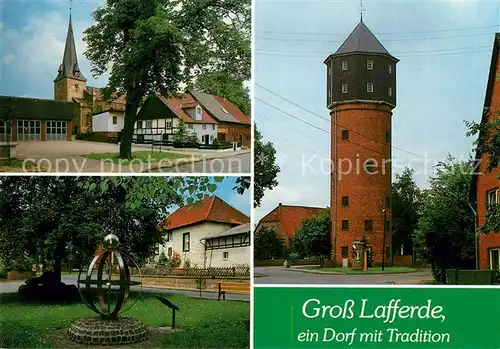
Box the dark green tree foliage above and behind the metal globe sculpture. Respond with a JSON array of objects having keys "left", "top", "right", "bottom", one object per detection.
[{"left": 0, "top": 177, "right": 221, "bottom": 280}]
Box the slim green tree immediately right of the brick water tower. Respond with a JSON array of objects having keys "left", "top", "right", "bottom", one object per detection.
[{"left": 391, "top": 168, "right": 422, "bottom": 254}]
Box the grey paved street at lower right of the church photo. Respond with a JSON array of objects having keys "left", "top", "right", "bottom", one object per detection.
[{"left": 151, "top": 153, "right": 251, "bottom": 173}]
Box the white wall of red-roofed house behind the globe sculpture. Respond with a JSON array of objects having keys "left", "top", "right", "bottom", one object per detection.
[{"left": 160, "top": 222, "right": 234, "bottom": 268}]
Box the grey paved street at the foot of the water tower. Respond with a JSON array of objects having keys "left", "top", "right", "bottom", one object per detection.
[{"left": 254, "top": 267, "right": 432, "bottom": 285}]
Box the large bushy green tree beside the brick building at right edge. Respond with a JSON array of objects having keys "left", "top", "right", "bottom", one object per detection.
[{"left": 414, "top": 157, "right": 475, "bottom": 282}]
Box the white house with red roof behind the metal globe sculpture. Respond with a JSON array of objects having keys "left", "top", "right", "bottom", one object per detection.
[{"left": 158, "top": 196, "right": 250, "bottom": 268}]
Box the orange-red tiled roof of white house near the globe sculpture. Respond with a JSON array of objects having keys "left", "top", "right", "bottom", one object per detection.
[{"left": 165, "top": 195, "right": 250, "bottom": 230}]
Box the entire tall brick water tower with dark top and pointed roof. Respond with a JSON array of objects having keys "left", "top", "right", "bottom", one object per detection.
[{"left": 324, "top": 19, "right": 399, "bottom": 266}]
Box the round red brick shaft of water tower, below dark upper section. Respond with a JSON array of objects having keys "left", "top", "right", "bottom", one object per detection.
[{"left": 330, "top": 103, "right": 392, "bottom": 265}]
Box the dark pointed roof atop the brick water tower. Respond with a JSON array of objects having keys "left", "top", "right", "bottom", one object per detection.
[{"left": 335, "top": 21, "right": 390, "bottom": 55}]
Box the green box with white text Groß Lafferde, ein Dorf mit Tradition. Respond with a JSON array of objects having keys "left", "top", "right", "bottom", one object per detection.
[{"left": 254, "top": 287, "right": 500, "bottom": 349}]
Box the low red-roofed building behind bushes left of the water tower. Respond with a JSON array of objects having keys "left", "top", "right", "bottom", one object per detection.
[{"left": 259, "top": 204, "right": 325, "bottom": 237}]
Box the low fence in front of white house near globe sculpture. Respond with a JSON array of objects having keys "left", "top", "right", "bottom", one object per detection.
[{"left": 136, "top": 266, "right": 250, "bottom": 279}]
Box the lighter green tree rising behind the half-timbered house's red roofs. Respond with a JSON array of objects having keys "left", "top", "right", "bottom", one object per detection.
[{"left": 194, "top": 71, "right": 251, "bottom": 117}]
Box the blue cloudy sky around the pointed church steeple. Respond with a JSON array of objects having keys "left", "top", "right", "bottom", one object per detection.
[{"left": 0, "top": 0, "right": 107, "bottom": 99}]
